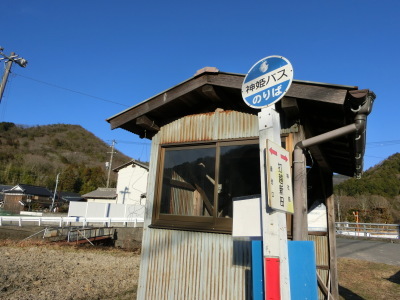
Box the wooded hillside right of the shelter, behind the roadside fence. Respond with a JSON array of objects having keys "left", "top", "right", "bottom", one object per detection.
[{"left": 335, "top": 153, "right": 400, "bottom": 223}]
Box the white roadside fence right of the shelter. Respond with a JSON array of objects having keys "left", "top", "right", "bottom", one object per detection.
[{"left": 336, "top": 222, "right": 400, "bottom": 239}]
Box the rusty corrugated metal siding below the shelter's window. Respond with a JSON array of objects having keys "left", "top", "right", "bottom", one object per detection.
[{"left": 138, "top": 229, "right": 251, "bottom": 300}]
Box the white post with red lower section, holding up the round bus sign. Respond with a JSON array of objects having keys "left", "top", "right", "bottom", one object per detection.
[{"left": 258, "top": 105, "right": 290, "bottom": 300}]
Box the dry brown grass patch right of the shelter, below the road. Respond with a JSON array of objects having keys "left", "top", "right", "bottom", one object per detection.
[{"left": 338, "top": 258, "right": 400, "bottom": 300}]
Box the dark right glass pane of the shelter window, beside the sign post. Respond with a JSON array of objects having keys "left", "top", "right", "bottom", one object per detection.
[{"left": 218, "top": 144, "right": 261, "bottom": 217}]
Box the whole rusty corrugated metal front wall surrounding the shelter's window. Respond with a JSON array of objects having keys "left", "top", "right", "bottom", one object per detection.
[{"left": 137, "top": 111, "right": 258, "bottom": 300}]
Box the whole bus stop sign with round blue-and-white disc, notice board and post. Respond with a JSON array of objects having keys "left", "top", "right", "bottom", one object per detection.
[{"left": 242, "top": 55, "right": 293, "bottom": 300}]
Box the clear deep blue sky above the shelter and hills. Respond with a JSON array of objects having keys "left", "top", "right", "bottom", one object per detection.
[{"left": 0, "top": 0, "right": 400, "bottom": 168}]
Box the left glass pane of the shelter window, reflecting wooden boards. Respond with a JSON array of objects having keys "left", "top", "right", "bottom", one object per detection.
[{"left": 160, "top": 147, "right": 215, "bottom": 216}]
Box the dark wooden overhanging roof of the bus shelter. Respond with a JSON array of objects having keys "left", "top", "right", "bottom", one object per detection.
[{"left": 107, "top": 68, "right": 375, "bottom": 176}]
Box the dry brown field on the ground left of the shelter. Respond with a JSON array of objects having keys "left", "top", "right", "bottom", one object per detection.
[{"left": 0, "top": 241, "right": 140, "bottom": 300}]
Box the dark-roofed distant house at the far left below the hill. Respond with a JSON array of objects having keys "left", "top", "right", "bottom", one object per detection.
[{"left": 3, "top": 184, "right": 52, "bottom": 213}]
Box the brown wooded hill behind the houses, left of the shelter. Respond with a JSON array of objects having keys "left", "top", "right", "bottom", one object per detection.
[{"left": 0, "top": 122, "right": 130, "bottom": 194}]
